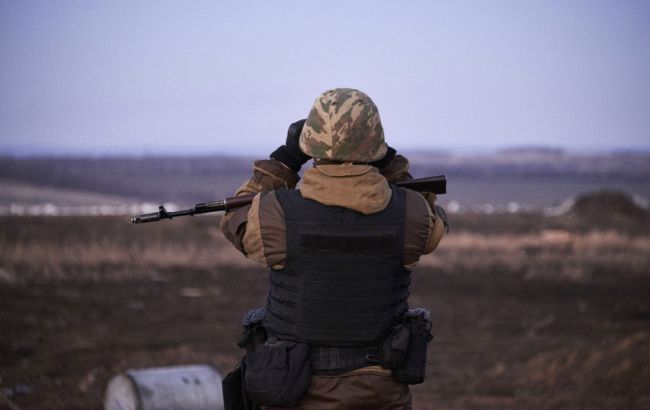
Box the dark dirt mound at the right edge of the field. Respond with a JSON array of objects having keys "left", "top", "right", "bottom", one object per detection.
[{"left": 569, "top": 191, "right": 648, "bottom": 223}]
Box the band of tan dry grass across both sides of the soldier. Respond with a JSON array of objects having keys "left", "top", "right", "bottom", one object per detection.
[{"left": 0, "top": 216, "right": 650, "bottom": 282}]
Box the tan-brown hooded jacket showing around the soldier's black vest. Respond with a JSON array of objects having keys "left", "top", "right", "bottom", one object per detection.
[{"left": 221, "top": 155, "right": 446, "bottom": 270}]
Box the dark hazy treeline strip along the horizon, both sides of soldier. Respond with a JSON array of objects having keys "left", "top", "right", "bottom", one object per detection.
[{"left": 0, "top": 150, "right": 650, "bottom": 203}]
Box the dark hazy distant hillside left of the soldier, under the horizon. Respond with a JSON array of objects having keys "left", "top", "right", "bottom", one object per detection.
[{"left": 0, "top": 156, "right": 252, "bottom": 203}]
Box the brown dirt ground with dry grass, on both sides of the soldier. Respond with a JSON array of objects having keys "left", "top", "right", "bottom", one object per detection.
[{"left": 0, "top": 215, "right": 650, "bottom": 410}]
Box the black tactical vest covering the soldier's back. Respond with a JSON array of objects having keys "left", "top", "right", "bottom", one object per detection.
[{"left": 263, "top": 187, "right": 411, "bottom": 346}]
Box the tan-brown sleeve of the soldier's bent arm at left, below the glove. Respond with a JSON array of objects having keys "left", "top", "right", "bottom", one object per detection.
[{"left": 220, "top": 159, "right": 300, "bottom": 260}]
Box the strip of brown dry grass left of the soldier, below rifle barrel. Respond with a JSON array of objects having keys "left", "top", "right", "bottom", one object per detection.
[{"left": 0, "top": 216, "right": 256, "bottom": 283}]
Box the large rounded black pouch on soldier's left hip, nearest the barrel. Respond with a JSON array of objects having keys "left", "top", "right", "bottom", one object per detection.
[{"left": 244, "top": 337, "right": 311, "bottom": 406}]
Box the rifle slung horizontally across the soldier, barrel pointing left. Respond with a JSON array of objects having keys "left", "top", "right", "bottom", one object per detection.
[{"left": 131, "top": 175, "right": 447, "bottom": 224}]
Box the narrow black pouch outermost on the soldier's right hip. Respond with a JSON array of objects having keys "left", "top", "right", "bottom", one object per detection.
[{"left": 393, "top": 308, "right": 433, "bottom": 384}]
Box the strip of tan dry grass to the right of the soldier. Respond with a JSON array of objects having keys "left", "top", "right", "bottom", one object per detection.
[{"left": 420, "top": 229, "right": 650, "bottom": 281}]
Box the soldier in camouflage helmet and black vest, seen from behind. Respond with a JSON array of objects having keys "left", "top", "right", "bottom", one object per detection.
[{"left": 221, "top": 88, "right": 447, "bottom": 409}]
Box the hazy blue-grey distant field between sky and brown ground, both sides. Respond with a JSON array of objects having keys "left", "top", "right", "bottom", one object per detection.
[{"left": 0, "top": 149, "right": 650, "bottom": 215}]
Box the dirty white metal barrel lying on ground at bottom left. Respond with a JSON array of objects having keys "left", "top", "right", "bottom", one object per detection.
[{"left": 104, "top": 365, "right": 223, "bottom": 410}]
